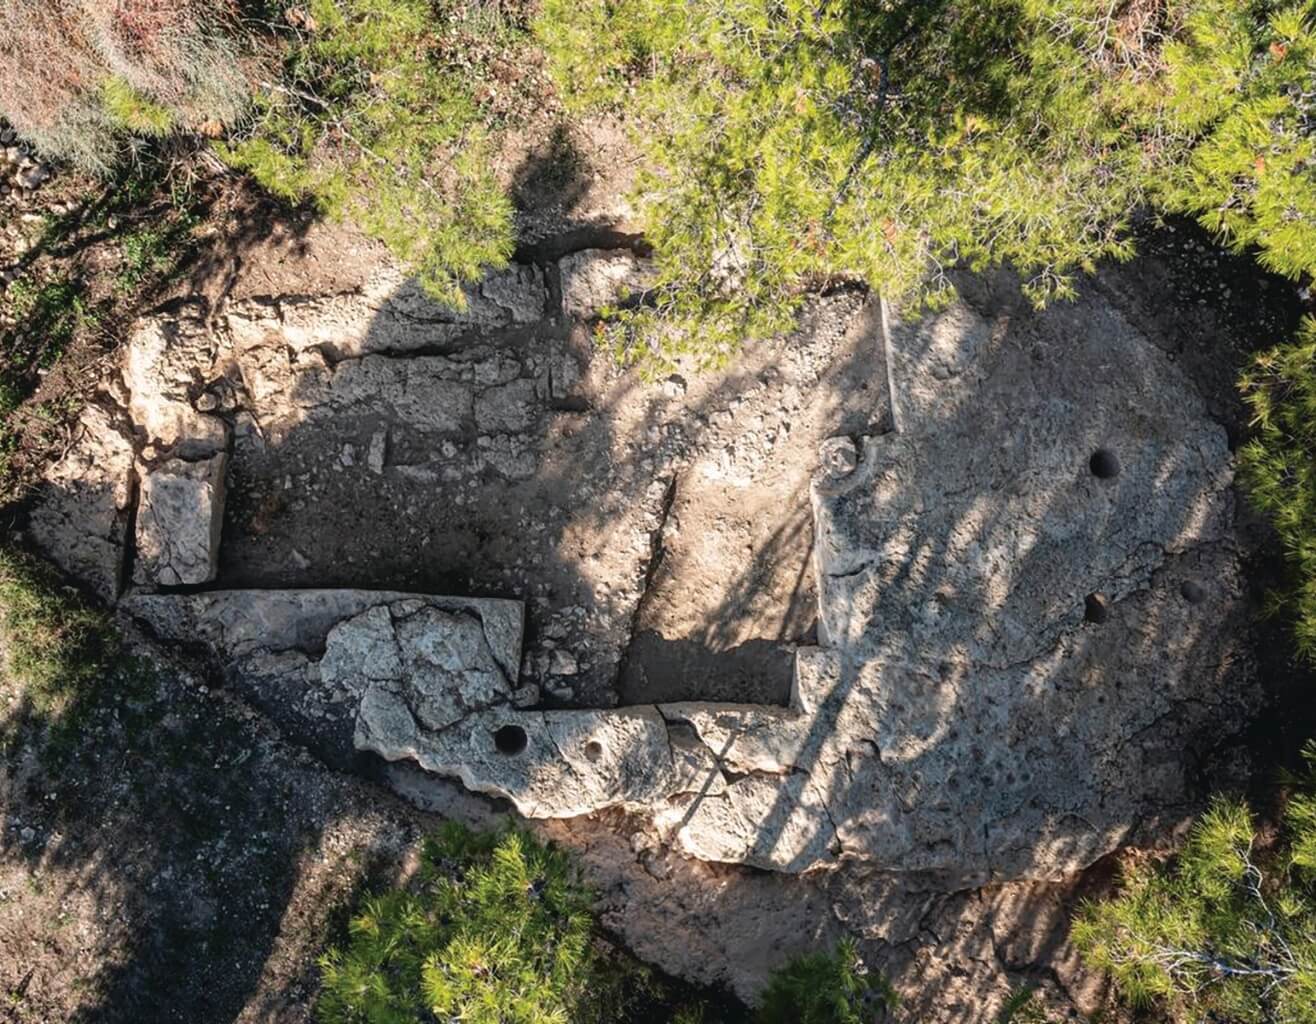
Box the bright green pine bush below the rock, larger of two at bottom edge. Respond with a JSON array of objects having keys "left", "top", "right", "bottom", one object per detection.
[{"left": 318, "top": 825, "right": 597, "bottom": 1024}]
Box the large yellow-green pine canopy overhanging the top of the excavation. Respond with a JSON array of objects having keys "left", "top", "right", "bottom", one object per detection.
[{"left": 537, "top": 0, "right": 1316, "bottom": 369}]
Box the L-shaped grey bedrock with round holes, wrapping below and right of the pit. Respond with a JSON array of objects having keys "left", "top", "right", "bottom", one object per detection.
[{"left": 118, "top": 282, "right": 1249, "bottom": 887}]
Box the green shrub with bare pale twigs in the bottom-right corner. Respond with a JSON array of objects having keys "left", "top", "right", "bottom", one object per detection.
[{"left": 1073, "top": 744, "right": 1316, "bottom": 1024}]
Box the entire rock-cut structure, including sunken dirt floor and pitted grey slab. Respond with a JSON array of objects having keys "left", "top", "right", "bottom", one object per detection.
[{"left": 32, "top": 244, "right": 1252, "bottom": 887}]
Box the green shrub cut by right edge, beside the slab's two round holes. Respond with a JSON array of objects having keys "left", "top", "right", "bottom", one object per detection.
[{"left": 1238, "top": 317, "right": 1316, "bottom": 659}]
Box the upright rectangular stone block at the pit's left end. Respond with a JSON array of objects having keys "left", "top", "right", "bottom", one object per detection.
[{"left": 133, "top": 451, "right": 228, "bottom": 587}]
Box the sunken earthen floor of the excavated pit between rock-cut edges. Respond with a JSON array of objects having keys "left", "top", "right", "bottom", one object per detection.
[{"left": 205, "top": 237, "right": 883, "bottom": 707}]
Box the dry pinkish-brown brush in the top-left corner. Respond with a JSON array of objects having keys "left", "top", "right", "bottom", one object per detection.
[{"left": 0, "top": 0, "right": 249, "bottom": 172}]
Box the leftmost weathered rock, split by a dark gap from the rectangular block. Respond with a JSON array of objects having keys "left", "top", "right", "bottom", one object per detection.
[{"left": 28, "top": 405, "right": 133, "bottom": 602}]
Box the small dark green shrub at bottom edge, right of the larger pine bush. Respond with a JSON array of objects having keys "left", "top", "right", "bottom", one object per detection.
[{"left": 755, "top": 940, "right": 896, "bottom": 1024}]
